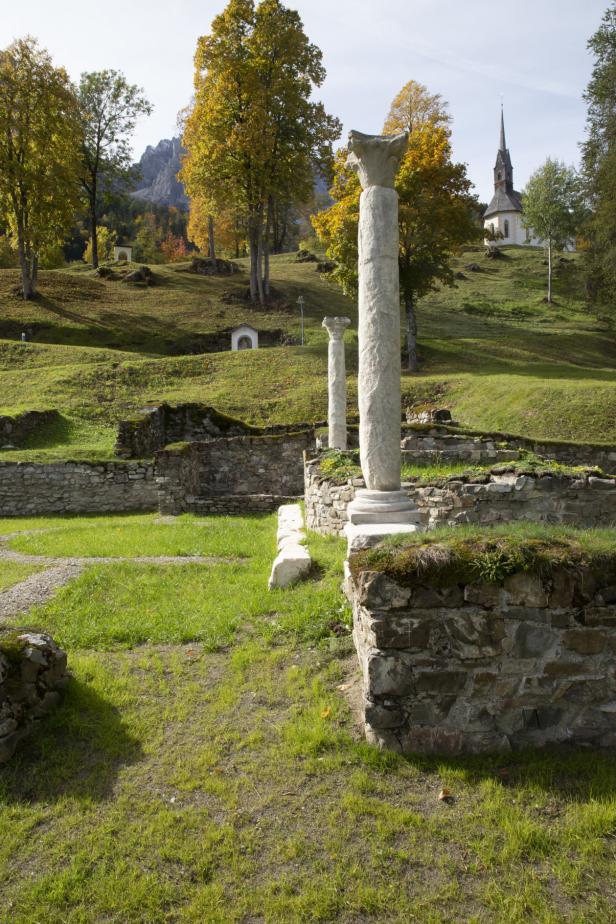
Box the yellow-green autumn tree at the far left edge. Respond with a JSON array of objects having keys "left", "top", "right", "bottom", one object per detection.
[{"left": 0, "top": 37, "right": 80, "bottom": 299}]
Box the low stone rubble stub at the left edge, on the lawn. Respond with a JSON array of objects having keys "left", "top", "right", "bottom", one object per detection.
[{"left": 0, "top": 631, "right": 68, "bottom": 764}]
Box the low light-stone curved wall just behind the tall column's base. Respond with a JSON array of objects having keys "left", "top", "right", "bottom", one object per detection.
[{"left": 305, "top": 459, "right": 616, "bottom": 535}]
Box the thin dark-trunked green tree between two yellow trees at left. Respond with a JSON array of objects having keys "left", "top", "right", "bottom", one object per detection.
[{"left": 78, "top": 70, "right": 152, "bottom": 268}]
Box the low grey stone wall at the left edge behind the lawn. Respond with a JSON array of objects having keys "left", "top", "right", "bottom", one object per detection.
[{"left": 0, "top": 462, "right": 158, "bottom": 516}]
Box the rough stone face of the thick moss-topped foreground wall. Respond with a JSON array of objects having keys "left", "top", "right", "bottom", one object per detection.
[{"left": 348, "top": 559, "right": 616, "bottom": 754}]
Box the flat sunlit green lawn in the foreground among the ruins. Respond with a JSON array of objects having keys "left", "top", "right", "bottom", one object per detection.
[{"left": 0, "top": 516, "right": 616, "bottom": 924}]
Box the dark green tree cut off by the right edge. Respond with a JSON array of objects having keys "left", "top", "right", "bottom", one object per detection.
[{"left": 582, "top": 3, "right": 616, "bottom": 305}]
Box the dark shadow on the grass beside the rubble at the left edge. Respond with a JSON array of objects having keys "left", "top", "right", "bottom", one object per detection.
[{"left": 0, "top": 678, "right": 143, "bottom": 803}]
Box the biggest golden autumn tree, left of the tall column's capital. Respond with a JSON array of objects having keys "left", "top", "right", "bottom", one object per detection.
[{"left": 181, "top": 0, "right": 340, "bottom": 303}]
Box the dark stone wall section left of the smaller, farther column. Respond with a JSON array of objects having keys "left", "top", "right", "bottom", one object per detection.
[{"left": 156, "top": 431, "right": 314, "bottom": 514}]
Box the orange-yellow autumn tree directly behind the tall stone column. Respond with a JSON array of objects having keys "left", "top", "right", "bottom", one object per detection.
[{"left": 313, "top": 81, "right": 482, "bottom": 372}]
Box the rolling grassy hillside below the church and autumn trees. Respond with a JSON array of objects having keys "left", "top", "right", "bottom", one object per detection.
[{"left": 0, "top": 248, "right": 616, "bottom": 459}]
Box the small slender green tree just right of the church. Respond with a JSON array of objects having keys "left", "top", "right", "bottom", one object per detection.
[{"left": 522, "top": 157, "right": 580, "bottom": 304}]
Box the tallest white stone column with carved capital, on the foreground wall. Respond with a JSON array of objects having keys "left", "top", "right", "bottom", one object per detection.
[{"left": 346, "top": 131, "right": 419, "bottom": 552}]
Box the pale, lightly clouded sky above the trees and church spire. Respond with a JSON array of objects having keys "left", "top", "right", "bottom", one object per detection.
[{"left": 0, "top": 0, "right": 609, "bottom": 201}]
